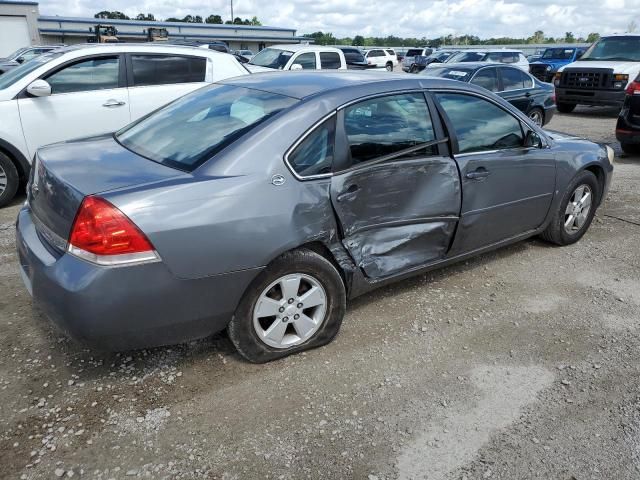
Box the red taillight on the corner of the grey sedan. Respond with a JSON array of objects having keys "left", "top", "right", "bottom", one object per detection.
[{"left": 69, "top": 197, "right": 154, "bottom": 257}]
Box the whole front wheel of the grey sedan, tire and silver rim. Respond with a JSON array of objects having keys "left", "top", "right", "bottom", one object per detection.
[{"left": 542, "top": 170, "right": 601, "bottom": 245}]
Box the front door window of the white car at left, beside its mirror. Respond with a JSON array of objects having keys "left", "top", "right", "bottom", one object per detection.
[{"left": 46, "top": 57, "right": 120, "bottom": 94}]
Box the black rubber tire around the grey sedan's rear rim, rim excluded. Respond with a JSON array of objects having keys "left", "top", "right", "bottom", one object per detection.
[{"left": 227, "top": 249, "right": 346, "bottom": 363}]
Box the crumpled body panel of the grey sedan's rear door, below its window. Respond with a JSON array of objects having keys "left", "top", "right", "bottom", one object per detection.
[{"left": 331, "top": 157, "right": 461, "bottom": 278}]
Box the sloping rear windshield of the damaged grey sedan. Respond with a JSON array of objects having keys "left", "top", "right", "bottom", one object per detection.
[{"left": 115, "top": 85, "right": 298, "bottom": 172}]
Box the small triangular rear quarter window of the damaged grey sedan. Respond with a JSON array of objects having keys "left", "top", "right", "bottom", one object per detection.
[{"left": 289, "top": 117, "right": 335, "bottom": 177}]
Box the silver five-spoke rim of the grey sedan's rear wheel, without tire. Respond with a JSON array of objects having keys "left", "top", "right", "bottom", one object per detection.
[{"left": 253, "top": 273, "right": 327, "bottom": 349}]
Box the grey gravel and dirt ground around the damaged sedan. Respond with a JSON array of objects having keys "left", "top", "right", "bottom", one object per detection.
[{"left": 0, "top": 109, "right": 640, "bottom": 480}]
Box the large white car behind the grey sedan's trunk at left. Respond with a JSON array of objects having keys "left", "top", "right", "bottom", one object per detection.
[{"left": 0, "top": 44, "right": 249, "bottom": 207}]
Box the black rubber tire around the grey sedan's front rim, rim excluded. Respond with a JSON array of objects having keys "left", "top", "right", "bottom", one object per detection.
[{"left": 541, "top": 170, "right": 601, "bottom": 245}]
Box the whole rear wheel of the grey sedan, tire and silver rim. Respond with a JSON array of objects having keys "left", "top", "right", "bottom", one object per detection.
[{"left": 227, "top": 249, "right": 346, "bottom": 363}]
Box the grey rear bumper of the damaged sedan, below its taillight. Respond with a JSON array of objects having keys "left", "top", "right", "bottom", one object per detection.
[{"left": 16, "top": 207, "right": 260, "bottom": 350}]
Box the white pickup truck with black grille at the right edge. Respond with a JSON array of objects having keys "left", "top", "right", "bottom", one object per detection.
[{"left": 553, "top": 33, "right": 640, "bottom": 113}]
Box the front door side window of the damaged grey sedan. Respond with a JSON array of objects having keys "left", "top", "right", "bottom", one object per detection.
[{"left": 436, "top": 93, "right": 524, "bottom": 153}]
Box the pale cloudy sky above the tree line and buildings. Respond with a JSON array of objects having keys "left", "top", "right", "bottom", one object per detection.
[{"left": 40, "top": 0, "right": 640, "bottom": 38}]
